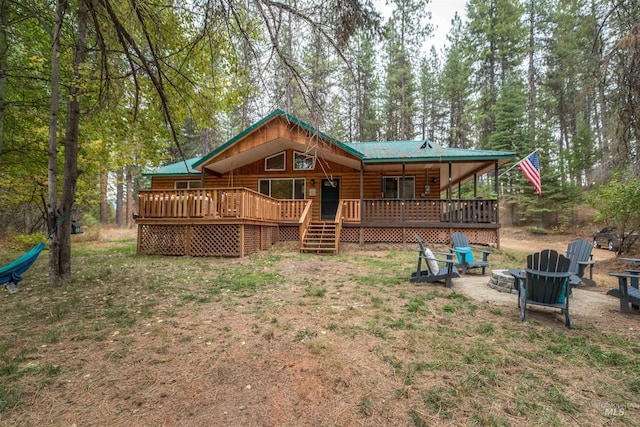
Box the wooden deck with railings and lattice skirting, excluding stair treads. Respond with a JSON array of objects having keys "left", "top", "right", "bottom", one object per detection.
[{"left": 136, "top": 188, "right": 500, "bottom": 256}]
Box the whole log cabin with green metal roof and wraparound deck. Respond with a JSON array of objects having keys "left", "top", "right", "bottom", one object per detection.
[{"left": 136, "top": 110, "right": 515, "bottom": 257}]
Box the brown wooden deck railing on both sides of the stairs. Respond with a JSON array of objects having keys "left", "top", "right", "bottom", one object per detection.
[{"left": 138, "top": 188, "right": 498, "bottom": 224}]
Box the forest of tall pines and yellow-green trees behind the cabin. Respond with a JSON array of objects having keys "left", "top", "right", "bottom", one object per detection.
[{"left": 0, "top": 0, "right": 640, "bottom": 263}]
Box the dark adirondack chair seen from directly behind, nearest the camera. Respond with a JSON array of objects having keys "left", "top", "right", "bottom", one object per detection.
[{"left": 518, "top": 249, "right": 573, "bottom": 329}]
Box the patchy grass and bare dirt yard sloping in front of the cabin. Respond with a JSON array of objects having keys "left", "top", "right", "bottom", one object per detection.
[{"left": 0, "top": 236, "right": 640, "bottom": 426}]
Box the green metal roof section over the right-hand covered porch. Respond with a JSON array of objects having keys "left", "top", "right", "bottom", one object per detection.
[{"left": 348, "top": 141, "right": 516, "bottom": 163}]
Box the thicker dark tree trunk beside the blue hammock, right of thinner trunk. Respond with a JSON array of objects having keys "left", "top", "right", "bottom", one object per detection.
[{"left": 49, "top": 0, "right": 89, "bottom": 286}]
